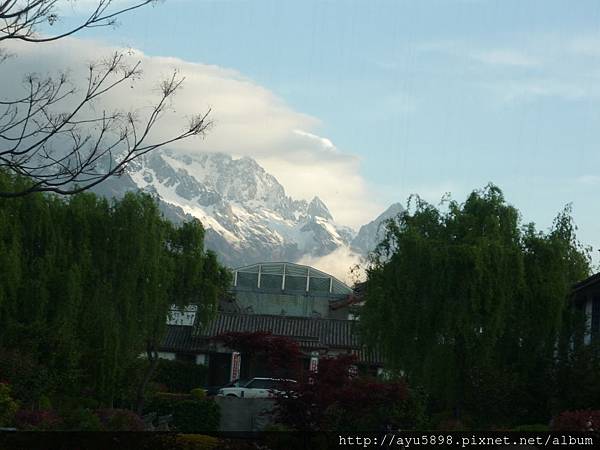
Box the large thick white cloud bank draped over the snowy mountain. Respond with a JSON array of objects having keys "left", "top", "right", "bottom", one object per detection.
[{"left": 0, "top": 38, "right": 385, "bottom": 227}]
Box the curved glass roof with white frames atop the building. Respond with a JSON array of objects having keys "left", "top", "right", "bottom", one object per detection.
[{"left": 233, "top": 262, "right": 352, "bottom": 295}]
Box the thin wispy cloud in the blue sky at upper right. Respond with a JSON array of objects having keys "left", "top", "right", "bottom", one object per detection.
[{"left": 417, "top": 34, "right": 600, "bottom": 106}]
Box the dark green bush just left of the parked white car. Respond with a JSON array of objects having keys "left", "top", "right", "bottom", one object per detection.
[{"left": 153, "top": 359, "right": 208, "bottom": 392}]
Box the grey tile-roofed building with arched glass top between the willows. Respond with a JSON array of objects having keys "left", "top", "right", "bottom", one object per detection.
[{"left": 160, "top": 263, "right": 382, "bottom": 385}]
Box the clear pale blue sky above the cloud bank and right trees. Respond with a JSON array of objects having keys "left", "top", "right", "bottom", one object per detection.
[{"left": 47, "top": 0, "right": 600, "bottom": 264}]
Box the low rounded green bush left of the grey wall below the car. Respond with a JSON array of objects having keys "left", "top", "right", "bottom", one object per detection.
[{"left": 173, "top": 399, "right": 221, "bottom": 433}]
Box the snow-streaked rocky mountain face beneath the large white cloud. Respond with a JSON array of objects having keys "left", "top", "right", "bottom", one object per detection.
[{"left": 123, "top": 150, "right": 354, "bottom": 266}]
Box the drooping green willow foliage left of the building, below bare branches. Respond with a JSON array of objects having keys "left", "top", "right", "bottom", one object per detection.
[{"left": 0, "top": 172, "right": 229, "bottom": 406}]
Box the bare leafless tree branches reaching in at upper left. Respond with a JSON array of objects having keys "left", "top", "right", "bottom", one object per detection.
[{"left": 0, "top": 0, "right": 210, "bottom": 198}]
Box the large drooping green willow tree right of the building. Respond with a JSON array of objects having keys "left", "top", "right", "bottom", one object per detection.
[{"left": 361, "top": 185, "right": 589, "bottom": 424}]
